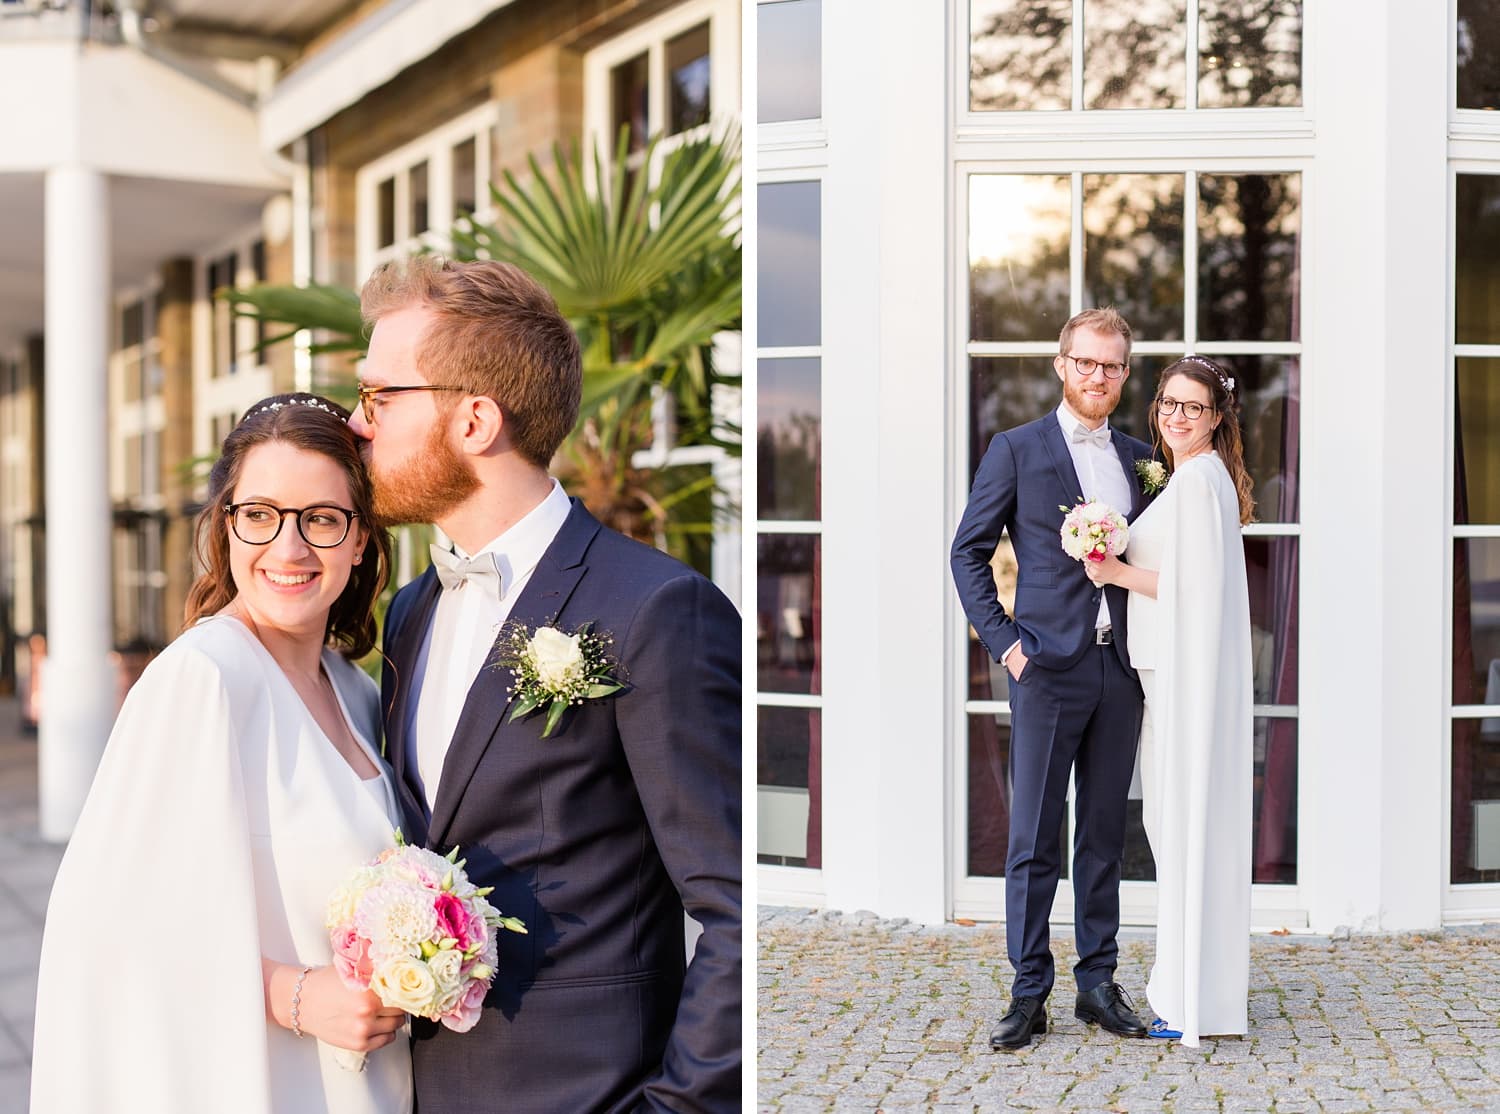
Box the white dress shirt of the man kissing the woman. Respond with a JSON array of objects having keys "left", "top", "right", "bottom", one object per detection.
[{"left": 408, "top": 480, "right": 572, "bottom": 813}]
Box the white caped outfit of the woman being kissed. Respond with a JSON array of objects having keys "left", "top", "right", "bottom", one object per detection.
[{"left": 32, "top": 616, "right": 411, "bottom": 1114}]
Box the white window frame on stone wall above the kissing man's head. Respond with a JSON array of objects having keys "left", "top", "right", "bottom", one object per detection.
[{"left": 354, "top": 100, "right": 500, "bottom": 282}]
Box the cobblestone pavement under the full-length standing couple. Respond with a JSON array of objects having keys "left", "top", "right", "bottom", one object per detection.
[{"left": 758, "top": 909, "right": 1500, "bottom": 1114}]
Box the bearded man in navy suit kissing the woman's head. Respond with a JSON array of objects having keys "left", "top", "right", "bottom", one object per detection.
[{"left": 350, "top": 256, "right": 741, "bottom": 1114}]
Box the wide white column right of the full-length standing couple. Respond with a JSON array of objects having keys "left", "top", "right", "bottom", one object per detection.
[{"left": 1298, "top": 0, "right": 1452, "bottom": 931}]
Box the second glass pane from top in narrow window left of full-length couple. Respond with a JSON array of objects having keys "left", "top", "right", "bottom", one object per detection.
[{"left": 758, "top": 181, "right": 822, "bottom": 348}]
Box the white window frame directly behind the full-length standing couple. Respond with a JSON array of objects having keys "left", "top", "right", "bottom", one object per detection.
[{"left": 947, "top": 0, "right": 1316, "bottom": 930}]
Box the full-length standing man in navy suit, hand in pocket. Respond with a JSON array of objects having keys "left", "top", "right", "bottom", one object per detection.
[{"left": 953, "top": 309, "right": 1151, "bottom": 1050}]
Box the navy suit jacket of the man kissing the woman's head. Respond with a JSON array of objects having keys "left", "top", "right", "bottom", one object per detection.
[{"left": 381, "top": 499, "right": 741, "bottom": 1114}]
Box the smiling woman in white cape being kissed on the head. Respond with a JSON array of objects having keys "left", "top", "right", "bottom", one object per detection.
[{"left": 32, "top": 394, "right": 411, "bottom": 1114}]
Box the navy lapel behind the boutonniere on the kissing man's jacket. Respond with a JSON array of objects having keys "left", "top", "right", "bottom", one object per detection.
[{"left": 428, "top": 499, "right": 600, "bottom": 847}]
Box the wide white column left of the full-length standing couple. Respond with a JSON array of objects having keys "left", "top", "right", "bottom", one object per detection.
[{"left": 822, "top": 0, "right": 953, "bottom": 922}]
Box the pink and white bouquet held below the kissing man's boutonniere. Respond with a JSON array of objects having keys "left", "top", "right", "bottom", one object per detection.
[{"left": 326, "top": 831, "right": 527, "bottom": 1071}]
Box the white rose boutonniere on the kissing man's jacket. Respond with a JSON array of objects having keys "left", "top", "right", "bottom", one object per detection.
[{"left": 495, "top": 622, "right": 626, "bottom": 739}]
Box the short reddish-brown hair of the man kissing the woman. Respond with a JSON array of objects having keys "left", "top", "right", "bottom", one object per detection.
[{"left": 360, "top": 255, "right": 584, "bottom": 468}]
